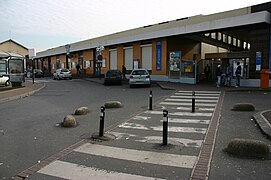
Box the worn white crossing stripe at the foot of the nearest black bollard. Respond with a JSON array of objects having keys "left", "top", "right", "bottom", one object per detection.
[{"left": 110, "top": 132, "right": 203, "bottom": 148}]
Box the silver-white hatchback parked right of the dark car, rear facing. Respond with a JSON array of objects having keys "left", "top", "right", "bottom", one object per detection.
[{"left": 129, "top": 69, "right": 151, "bottom": 87}]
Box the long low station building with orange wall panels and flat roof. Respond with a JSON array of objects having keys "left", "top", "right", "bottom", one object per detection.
[{"left": 36, "top": 2, "right": 271, "bottom": 86}]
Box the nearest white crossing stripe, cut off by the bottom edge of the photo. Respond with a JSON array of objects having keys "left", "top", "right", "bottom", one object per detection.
[{"left": 38, "top": 160, "right": 166, "bottom": 180}]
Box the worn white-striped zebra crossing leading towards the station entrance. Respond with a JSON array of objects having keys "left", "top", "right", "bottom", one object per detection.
[{"left": 38, "top": 91, "right": 220, "bottom": 179}]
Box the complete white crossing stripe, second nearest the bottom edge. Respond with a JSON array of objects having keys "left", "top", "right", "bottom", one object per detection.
[{"left": 74, "top": 143, "right": 197, "bottom": 168}]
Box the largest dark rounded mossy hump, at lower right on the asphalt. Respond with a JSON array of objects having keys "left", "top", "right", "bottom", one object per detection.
[{"left": 225, "top": 138, "right": 270, "bottom": 159}]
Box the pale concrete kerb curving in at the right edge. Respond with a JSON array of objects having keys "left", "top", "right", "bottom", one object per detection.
[{"left": 253, "top": 110, "right": 271, "bottom": 138}]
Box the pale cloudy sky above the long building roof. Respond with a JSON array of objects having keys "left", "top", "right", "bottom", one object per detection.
[{"left": 0, "top": 0, "right": 268, "bottom": 51}]
